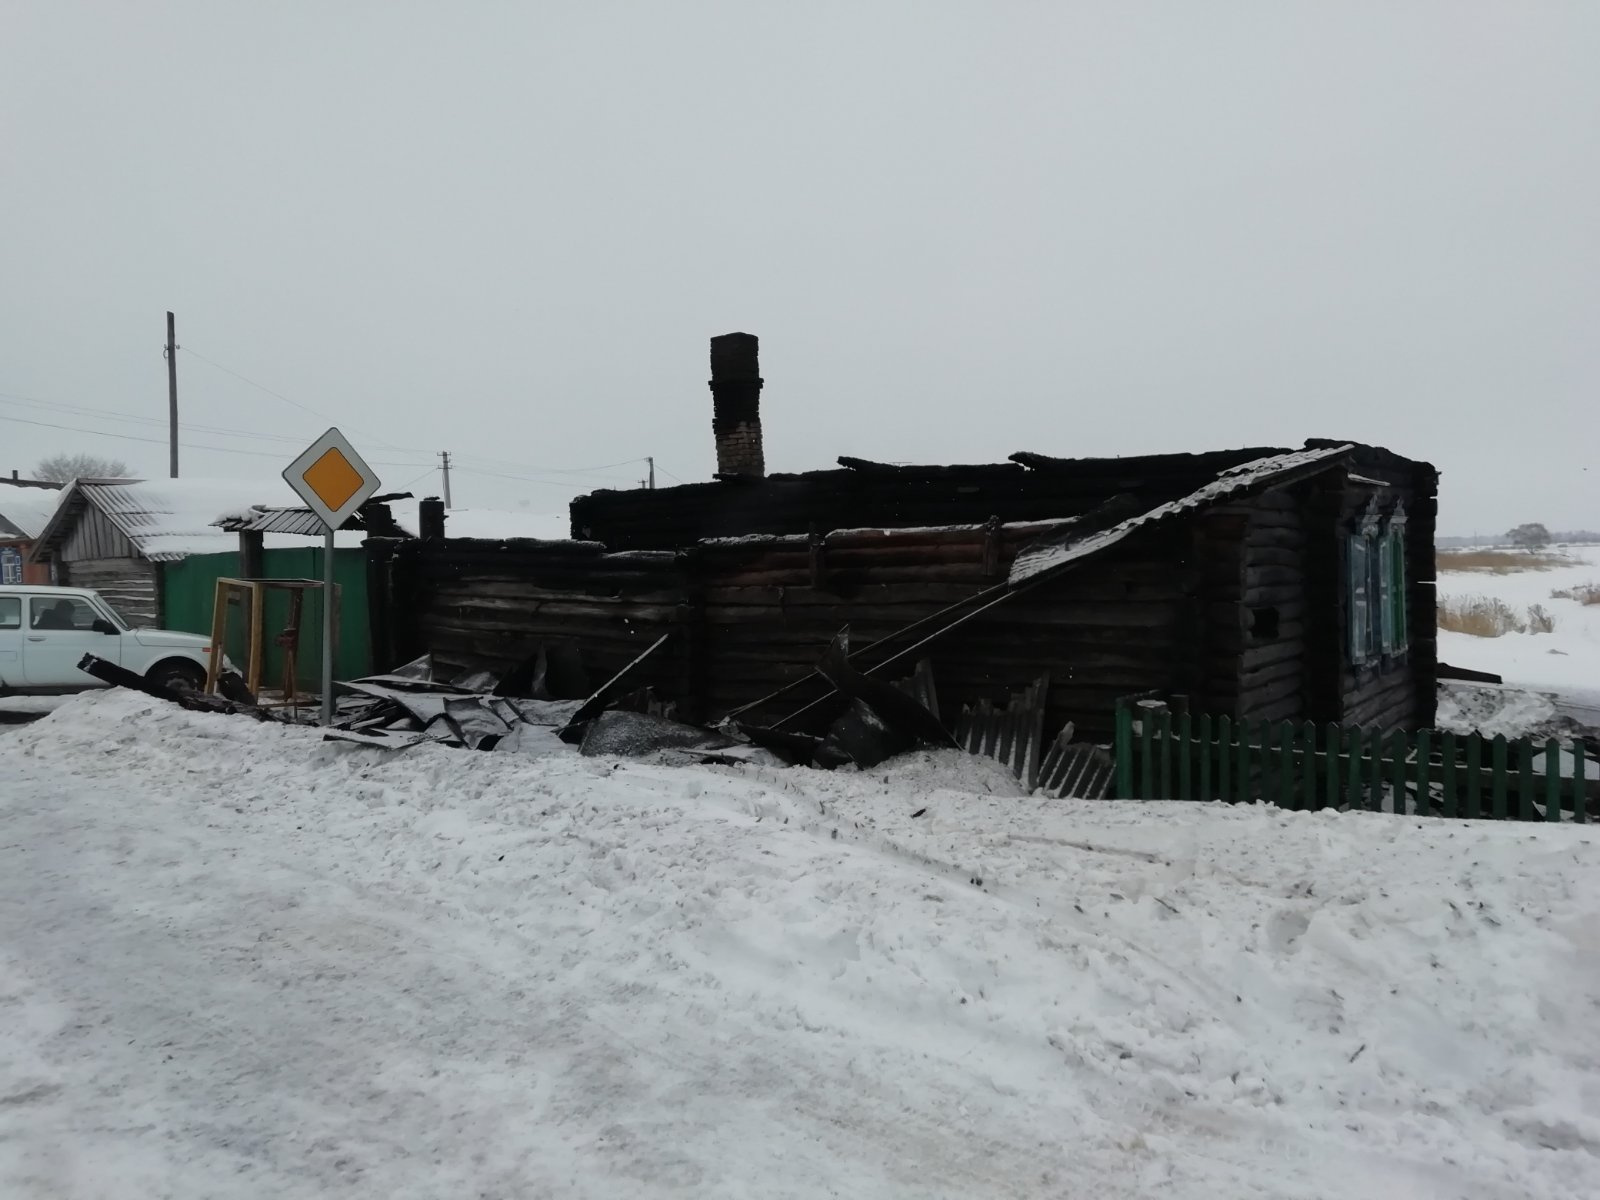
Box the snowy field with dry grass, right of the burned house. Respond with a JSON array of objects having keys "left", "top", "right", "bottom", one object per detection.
[{"left": 1437, "top": 546, "right": 1600, "bottom": 723}]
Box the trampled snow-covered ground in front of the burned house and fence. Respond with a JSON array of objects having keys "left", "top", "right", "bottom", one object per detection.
[{"left": 0, "top": 693, "right": 1600, "bottom": 1200}]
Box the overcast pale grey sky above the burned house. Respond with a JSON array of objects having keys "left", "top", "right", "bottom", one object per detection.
[{"left": 0, "top": 0, "right": 1600, "bottom": 533}]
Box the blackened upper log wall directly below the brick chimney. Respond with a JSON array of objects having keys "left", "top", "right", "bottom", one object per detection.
[{"left": 571, "top": 448, "right": 1275, "bottom": 550}]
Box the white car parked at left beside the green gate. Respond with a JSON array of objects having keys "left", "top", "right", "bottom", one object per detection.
[{"left": 0, "top": 584, "right": 220, "bottom": 696}]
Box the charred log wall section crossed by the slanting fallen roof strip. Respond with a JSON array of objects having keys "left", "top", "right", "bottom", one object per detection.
[{"left": 696, "top": 525, "right": 1197, "bottom": 736}]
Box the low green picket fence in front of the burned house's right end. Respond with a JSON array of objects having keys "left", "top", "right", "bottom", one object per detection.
[{"left": 1114, "top": 702, "right": 1600, "bottom": 822}]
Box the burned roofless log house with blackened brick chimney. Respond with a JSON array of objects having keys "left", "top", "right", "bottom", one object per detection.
[{"left": 374, "top": 334, "right": 1437, "bottom": 736}]
